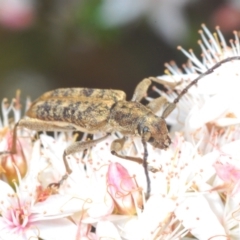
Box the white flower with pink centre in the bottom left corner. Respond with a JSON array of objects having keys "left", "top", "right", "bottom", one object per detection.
[{"left": 0, "top": 146, "right": 79, "bottom": 240}]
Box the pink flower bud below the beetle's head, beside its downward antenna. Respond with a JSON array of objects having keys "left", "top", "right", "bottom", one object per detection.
[{"left": 107, "top": 163, "right": 142, "bottom": 215}]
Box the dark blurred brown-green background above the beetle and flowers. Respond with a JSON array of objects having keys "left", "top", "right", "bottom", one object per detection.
[{"left": 0, "top": 0, "right": 240, "bottom": 99}]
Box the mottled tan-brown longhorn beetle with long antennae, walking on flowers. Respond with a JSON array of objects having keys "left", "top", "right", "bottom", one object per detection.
[{"left": 1, "top": 56, "right": 240, "bottom": 198}]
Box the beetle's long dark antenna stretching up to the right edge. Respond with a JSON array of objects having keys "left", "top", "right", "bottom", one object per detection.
[{"left": 173, "top": 56, "right": 240, "bottom": 104}]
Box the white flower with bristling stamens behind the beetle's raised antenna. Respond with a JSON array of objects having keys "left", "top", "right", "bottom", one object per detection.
[{"left": 149, "top": 25, "right": 240, "bottom": 148}]
